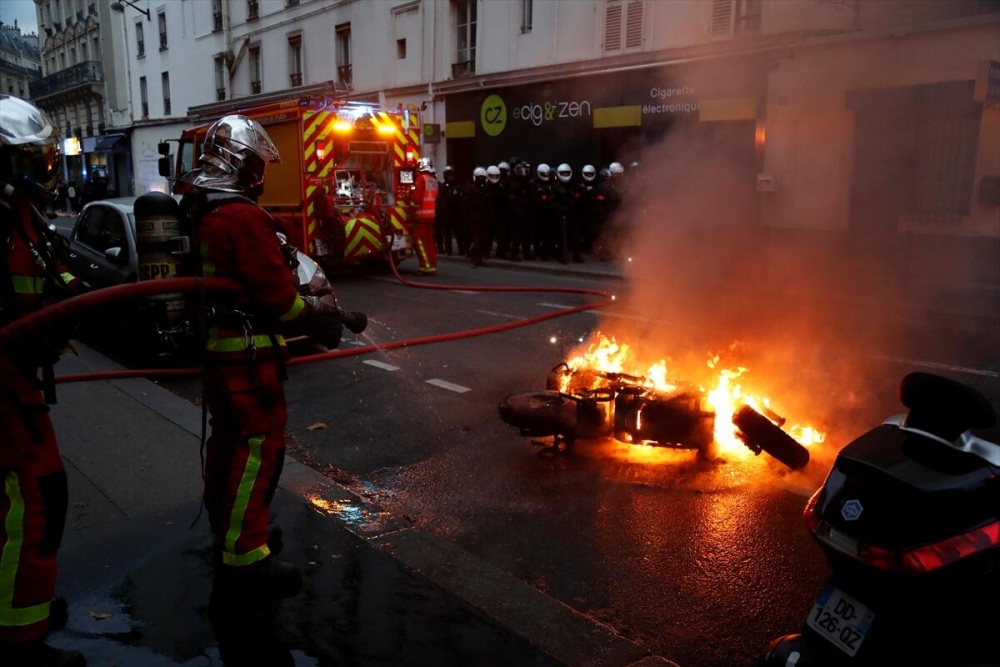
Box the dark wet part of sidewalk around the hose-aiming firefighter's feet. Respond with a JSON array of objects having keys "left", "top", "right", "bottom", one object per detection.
[{"left": 52, "top": 490, "right": 561, "bottom": 667}]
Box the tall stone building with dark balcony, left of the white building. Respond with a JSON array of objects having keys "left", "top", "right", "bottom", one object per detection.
[{"left": 30, "top": 0, "right": 132, "bottom": 194}]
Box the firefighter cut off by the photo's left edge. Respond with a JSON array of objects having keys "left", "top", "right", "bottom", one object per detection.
[{"left": 0, "top": 95, "right": 86, "bottom": 667}]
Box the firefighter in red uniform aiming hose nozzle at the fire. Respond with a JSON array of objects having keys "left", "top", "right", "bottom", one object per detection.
[{"left": 181, "top": 115, "right": 367, "bottom": 652}]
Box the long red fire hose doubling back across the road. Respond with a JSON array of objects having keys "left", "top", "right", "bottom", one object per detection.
[{"left": 0, "top": 260, "right": 614, "bottom": 383}]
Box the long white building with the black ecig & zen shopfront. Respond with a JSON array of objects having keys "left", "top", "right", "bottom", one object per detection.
[{"left": 126, "top": 0, "right": 1000, "bottom": 278}]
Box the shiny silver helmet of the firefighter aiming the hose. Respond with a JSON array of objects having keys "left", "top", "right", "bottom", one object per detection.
[{"left": 184, "top": 114, "right": 281, "bottom": 193}]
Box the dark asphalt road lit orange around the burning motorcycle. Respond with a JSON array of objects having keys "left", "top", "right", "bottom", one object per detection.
[{"left": 143, "top": 262, "right": 1000, "bottom": 667}]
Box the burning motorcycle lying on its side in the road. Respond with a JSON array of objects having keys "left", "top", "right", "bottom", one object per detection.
[{"left": 499, "top": 363, "right": 809, "bottom": 469}]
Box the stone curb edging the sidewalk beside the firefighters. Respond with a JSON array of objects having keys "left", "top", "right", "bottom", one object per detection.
[{"left": 68, "top": 341, "right": 679, "bottom": 667}]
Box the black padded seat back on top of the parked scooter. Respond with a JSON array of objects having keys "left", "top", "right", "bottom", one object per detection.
[{"left": 899, "top": 373, "right": 997, "bottom": 441}]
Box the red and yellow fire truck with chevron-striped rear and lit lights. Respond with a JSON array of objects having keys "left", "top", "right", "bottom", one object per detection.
[{"left": 159, "top": 84, "right": 421, "bottom": 269}]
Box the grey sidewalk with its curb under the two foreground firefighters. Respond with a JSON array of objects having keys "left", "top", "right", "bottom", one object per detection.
[{"left": 43, "top": 346, "right": 674, "bottom": 667}]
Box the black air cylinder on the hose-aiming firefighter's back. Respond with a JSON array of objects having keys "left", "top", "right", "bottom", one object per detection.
[{"left": 133, "top": 192, "right": 194, "bottom": 324}]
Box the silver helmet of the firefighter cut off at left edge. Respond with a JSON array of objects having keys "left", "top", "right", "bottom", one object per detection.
[{"left": 0, "top": 95, "right": 61, "bottom": 199}]
